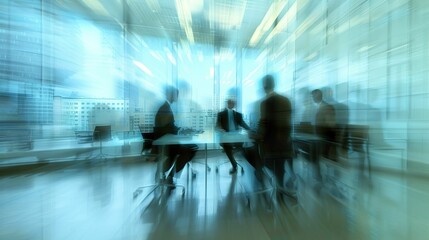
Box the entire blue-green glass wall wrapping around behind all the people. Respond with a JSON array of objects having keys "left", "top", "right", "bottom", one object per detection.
[{"left": 0, "top": 0, "right": 429, "bottom": 171}]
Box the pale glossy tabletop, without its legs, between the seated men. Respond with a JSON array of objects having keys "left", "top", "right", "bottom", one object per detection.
[{"left": 153, "top": 132, "right": 252, "bottom": 145}]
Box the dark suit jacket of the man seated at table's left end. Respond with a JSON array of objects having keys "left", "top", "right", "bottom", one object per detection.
[{"left": 154, "top": 101, "right": 179, "bottom": 139}]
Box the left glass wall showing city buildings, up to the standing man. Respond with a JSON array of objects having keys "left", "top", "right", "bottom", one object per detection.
[{"left": 0, "top": 0, "right": 266, "bottom": 163}]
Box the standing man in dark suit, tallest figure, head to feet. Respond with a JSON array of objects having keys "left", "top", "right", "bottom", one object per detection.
[{"left": 251, "top": 75, "right": 295, "bottom": 190}]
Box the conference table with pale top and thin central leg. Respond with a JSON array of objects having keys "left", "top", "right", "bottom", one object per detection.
[{"left": 152, "top": 131, "right": 253, "bottom": 199}]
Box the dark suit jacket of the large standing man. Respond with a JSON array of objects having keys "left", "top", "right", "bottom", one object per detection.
[{"left": 257, "top": 93, "right": 293, "bottom": 158}]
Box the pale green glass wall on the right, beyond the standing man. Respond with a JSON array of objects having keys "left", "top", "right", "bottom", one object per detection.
[{"left": 268, "top": 0, "right": 429, "bottom": 169}]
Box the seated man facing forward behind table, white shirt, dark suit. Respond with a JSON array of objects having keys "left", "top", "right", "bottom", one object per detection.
[{"left": 216, "top": 99, "right": 250, "bottom": 174}]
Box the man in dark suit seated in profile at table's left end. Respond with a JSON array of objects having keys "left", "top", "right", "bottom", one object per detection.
[{"left": 154, "top": 86, "right": 198, "bottom": 184}]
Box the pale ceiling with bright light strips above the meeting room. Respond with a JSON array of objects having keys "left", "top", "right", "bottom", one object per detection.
[{"left": 51, "top": 0, "right": 276, "bottom": 47}]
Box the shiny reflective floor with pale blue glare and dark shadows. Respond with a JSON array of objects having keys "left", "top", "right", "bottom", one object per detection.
[{"left": 0, "top": 151, "right": 429, "bottom": 239}]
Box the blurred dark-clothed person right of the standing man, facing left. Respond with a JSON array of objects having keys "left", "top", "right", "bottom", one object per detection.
[{"left": 311, "top": 89, "right": 337, "bottom": 160}]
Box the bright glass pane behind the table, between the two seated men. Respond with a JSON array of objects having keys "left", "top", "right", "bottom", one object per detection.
[{"left": 175, "top": 43, "right": 217, "bottom": 131}]
